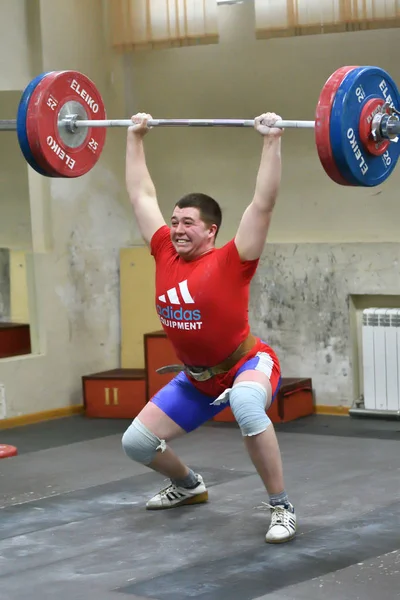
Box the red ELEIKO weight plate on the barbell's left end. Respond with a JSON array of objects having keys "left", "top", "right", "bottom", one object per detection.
[{"left": 26, "top": 71, "right": 106, "bottom": 177}]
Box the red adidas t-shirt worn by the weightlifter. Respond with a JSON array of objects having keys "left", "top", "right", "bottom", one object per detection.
[{"left": 151, "top": 225, "right": 259, "bottom": 367}]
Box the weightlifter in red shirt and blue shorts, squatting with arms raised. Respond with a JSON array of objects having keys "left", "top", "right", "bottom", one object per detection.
[{"left": 122, "top": 113, "right": 296, "bottom": 543}]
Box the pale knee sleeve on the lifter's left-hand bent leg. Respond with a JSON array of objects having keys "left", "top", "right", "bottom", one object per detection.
[{"left": 122, "top": 417, "right": 167, "bottom": 465}]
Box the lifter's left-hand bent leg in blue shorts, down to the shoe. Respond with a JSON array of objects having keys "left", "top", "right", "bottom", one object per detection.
[{"left": 122, "top": 373, "right": 221, "bottom": 509}]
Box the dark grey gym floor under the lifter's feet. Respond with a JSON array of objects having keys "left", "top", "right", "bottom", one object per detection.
[{"left": 0, "top": 416, "right": 400, "bottom": 600}]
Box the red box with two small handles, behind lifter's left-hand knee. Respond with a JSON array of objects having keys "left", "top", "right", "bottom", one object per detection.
[{"left": 82, "top": 369, "right": 146, "bottom": 419}]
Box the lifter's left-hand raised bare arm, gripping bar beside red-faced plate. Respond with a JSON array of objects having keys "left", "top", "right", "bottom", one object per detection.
[{"left": 126, "top": 113, "right": 165, "bottom": 244}]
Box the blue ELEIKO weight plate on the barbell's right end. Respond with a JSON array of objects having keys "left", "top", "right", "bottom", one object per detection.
[{"left": 330, "top": 66, "right": 400, "bottom": 187}]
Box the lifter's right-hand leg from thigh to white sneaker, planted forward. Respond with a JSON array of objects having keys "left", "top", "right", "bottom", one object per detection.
[{"left": 230, "top": 353, "right": 296, "bottom": 543}]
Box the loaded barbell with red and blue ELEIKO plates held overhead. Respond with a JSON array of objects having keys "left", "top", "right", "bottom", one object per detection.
[{"left": 0, "top": 66, "right": 400, "bottom": 187}]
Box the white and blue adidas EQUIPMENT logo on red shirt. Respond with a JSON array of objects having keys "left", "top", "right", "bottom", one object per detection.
[{"left": 156, "top": 280, "right": 202, "bottom": 329}]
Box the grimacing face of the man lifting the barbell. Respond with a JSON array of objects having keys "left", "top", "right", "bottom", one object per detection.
[{"left": 171, "top": 206, "right": 217, "bottom": 260}]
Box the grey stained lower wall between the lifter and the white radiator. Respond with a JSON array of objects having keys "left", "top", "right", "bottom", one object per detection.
[{"left": 250, "top": 243, "right": 400, "bottom": 406}]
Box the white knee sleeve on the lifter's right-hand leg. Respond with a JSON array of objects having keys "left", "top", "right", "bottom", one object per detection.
[{"left": 229, "top": 381, "right": 271, "bottom": 436}]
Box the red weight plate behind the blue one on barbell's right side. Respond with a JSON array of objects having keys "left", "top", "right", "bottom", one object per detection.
[{"left": 315, "top": 66, "right": 356, "bottom": 185}]
